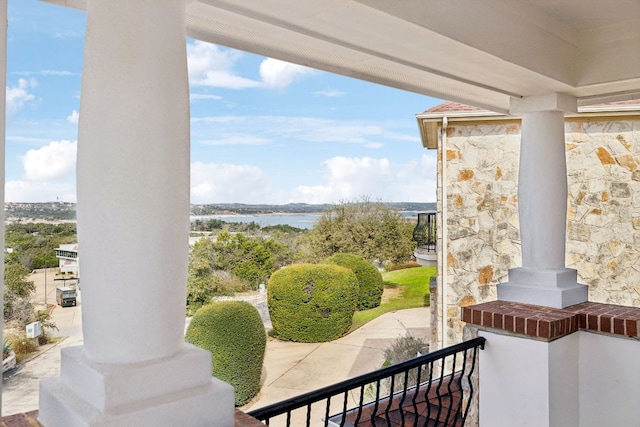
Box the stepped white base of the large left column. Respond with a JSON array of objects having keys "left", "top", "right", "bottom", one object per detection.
[{"left": 39, "top": 344, "right": 234, "bottom": 427}]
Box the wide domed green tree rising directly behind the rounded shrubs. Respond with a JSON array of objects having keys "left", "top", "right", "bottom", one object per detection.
[{"left": 305, "top": 198, "right": 415, "bottom": 263}]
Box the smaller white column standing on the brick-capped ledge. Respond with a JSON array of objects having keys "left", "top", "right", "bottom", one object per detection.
[{"left": 498, "top": 94, "right": 588, "bottom": 308}]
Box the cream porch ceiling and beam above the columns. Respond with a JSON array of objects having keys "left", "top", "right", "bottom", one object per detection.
[{"left": 45, "top": 0, "right": 640, "bottom": 112}]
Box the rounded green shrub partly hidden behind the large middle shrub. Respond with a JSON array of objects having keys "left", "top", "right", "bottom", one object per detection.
[{"left": 324, "top": 253, "right": 384, "bottom": 310}]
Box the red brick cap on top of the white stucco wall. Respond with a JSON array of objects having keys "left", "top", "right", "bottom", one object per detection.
[{"left": 462, "top": 301, "right": 640, "bottom": 341}]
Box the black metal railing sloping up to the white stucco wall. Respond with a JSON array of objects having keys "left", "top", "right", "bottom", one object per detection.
[{"left": 248, "top": 337, "right": 485, "bottom": 427}]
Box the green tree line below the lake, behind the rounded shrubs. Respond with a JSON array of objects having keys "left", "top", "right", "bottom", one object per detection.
[{"left": 5, "top": 198, "right": 415, "bottom": 317}]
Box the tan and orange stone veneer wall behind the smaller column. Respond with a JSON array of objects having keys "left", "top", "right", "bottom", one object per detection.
[{"left": 436, "top": 115, "right": 640, "bottom": 345}]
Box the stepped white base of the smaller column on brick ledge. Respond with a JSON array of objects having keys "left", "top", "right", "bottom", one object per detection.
[{"left": 497, "top": 267, "right": 589, "bottom": 308}]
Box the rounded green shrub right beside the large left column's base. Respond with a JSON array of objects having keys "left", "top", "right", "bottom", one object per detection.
[{"left": 185, "top": 301, "right": 267, "bottom": 406}]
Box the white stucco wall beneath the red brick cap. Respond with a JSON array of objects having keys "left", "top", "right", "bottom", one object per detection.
[{"left": 478, "top": 331, "right": 640, "bottom": 427}]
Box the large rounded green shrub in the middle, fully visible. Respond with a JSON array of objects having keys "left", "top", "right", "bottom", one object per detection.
[{"left": 267, "top": 264, "right": 358, "bottom": 342}]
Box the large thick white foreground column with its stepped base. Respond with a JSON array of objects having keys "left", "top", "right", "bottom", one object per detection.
[{"left": 40, "top": 0, "right": 233, "bottom": 427}]
